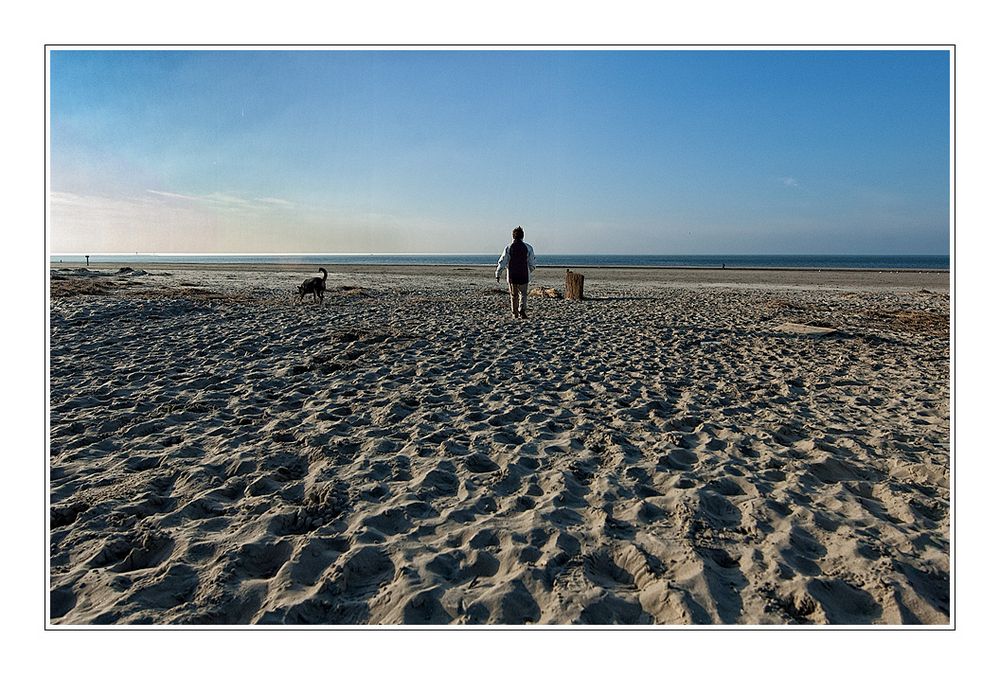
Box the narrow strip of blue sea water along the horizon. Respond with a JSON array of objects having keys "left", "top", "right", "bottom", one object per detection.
[{"left": 50, "top": 251, "right": 950, "bottom": 270}]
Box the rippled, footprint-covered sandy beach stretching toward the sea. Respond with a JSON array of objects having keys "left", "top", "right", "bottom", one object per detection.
[{"left": 49, "top": 265, "right": 951, "bottom": 625}]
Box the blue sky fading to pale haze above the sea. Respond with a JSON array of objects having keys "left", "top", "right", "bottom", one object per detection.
[{"left": 47, "top": 48, "right": 951, "bottom": 255}]
